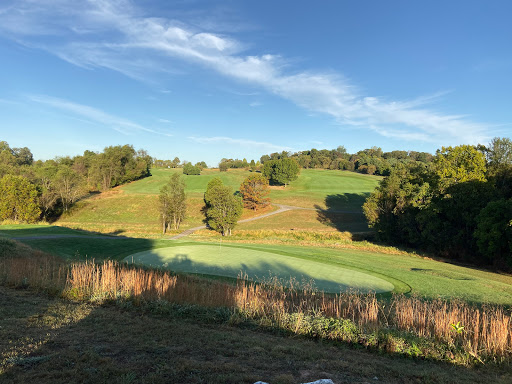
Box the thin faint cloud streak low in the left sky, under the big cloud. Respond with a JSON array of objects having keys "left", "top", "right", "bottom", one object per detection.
[{"left": 27, "top": 95, "right": 171, "bottom": 136}]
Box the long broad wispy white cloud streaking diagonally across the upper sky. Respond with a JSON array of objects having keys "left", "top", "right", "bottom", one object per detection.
[{"left": 0, "top": 0, "right": 490, "bottom": 144}]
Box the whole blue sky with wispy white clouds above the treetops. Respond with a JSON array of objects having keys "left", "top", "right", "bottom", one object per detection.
[{"left": 0, "top": 0, "right": 512, "bottom": 166}]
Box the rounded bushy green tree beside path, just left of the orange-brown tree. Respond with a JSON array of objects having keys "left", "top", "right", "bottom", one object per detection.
[{"left": 205, "top": 184, "right": 243, "bottom": 236}]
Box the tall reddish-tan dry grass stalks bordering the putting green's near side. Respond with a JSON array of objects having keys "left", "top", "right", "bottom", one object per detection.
[{"left": 0, "top": 240, "right": 512, "bottom": 360}]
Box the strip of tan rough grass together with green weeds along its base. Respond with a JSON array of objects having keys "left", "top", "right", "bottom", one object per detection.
[{"left": 0, "top": 242, "right": 512, "bottom": 370}]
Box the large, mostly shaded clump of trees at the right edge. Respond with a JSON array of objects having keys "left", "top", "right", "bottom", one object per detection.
[{"left": 363, "top": 138, "right": 512, "bottom": 270}]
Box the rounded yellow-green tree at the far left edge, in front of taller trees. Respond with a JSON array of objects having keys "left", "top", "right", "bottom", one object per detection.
[{"left": 0, "top": 175, "right": 41, "bottom": 223}]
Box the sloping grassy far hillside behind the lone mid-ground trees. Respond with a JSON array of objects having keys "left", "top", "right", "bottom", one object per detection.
[{"left": 57, "top": 168, "right": 380, "bottom": 237}]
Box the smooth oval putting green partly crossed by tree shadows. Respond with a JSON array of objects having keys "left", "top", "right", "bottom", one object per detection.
[{"left": 124, "top": 244, "right": 394, "bottom": 293}]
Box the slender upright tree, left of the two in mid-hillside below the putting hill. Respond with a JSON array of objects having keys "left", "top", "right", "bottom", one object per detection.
[{"left": 159, "top": 173, "right": 187, "bottom": 234}]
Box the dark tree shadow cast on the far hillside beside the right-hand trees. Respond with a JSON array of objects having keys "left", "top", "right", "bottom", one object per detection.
[{"left": 315, "top": 193, "right": 370, "bottom": 233}]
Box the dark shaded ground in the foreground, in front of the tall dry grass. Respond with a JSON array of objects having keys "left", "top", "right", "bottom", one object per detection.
[{"left": 0, "top": 287, "right": 512, "bottom": 384}]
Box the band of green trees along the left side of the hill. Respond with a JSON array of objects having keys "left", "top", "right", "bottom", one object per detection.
[{"left": 0, "top": 141, "right": 152, "bottom": 222}]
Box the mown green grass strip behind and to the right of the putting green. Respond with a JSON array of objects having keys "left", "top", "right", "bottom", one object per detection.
[{"left": 0, "top": 225, "right": 512, "bottom": 306}]
